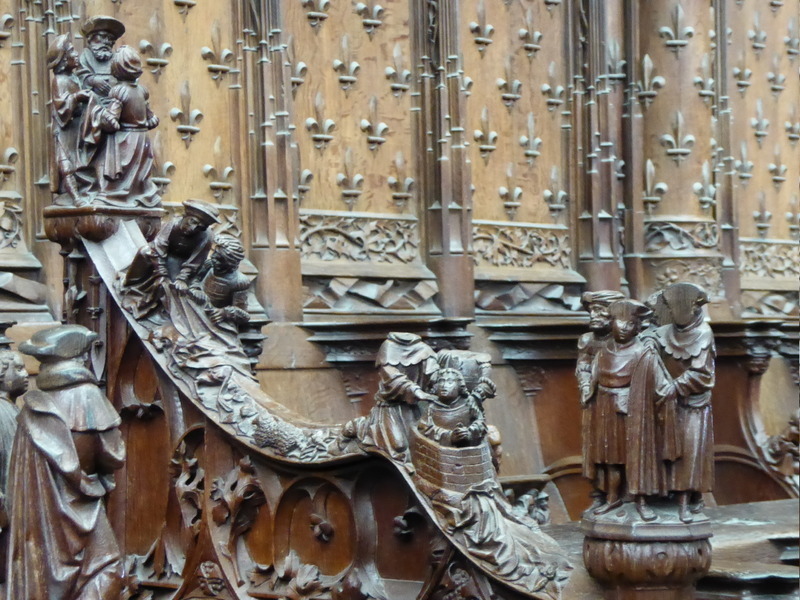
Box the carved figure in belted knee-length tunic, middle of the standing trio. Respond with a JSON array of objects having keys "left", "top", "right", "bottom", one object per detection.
[{"left": 586, "top": 300, "right": 650, "bottom": 518}]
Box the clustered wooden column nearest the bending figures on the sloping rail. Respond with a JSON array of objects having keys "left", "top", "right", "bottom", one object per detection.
[{"left": 244, "top": 0, "right": 302, "bottom": 321}]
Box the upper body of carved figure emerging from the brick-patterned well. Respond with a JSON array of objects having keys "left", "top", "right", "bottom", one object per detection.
[{"left": 417, "top": 369, "right": 486, "bottom": 448}]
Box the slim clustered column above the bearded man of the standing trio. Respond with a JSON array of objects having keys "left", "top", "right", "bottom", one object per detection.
[{"left": 576, "top": 0, "right": 626, "bottom": 289}]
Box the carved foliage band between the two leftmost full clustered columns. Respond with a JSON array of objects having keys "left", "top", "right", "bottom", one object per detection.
[{"left": 300, "top": 211, "right": 420, "bottom": 264}]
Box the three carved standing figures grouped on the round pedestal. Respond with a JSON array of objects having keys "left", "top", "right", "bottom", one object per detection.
[{"left": 576, "top": 283, "right": 715, "bottom": 523}]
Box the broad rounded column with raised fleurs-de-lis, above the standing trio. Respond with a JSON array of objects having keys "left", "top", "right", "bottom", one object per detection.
[{"left": 625, "top": 0, "right": 724, "bottom": 298}]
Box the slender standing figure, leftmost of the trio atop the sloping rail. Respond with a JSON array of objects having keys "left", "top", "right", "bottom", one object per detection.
[{"left": 47, "top": 35, "right": 91, "bottom": 206}]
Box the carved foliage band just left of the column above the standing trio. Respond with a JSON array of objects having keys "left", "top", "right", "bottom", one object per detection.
[{"left": 472, "top": 220, "right": 572, "bottom": 269}]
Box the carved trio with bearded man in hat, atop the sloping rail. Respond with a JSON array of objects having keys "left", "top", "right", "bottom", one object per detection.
[{"left": 47, "top": 16, "right": 161, "bottom": 207}]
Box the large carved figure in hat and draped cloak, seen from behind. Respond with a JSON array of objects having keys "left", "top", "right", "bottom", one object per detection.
[{"left": 7, "top": 325, "right": 125, "bottom": 600}]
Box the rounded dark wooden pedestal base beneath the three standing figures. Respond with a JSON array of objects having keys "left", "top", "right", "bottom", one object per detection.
[{"left": 581, "top": 503, "right": 711, "bottom": 600}]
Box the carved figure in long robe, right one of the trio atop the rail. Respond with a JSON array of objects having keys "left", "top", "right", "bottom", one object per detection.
[{"left": 83, "top": 46, "right": 161, "bottom": 207}]
